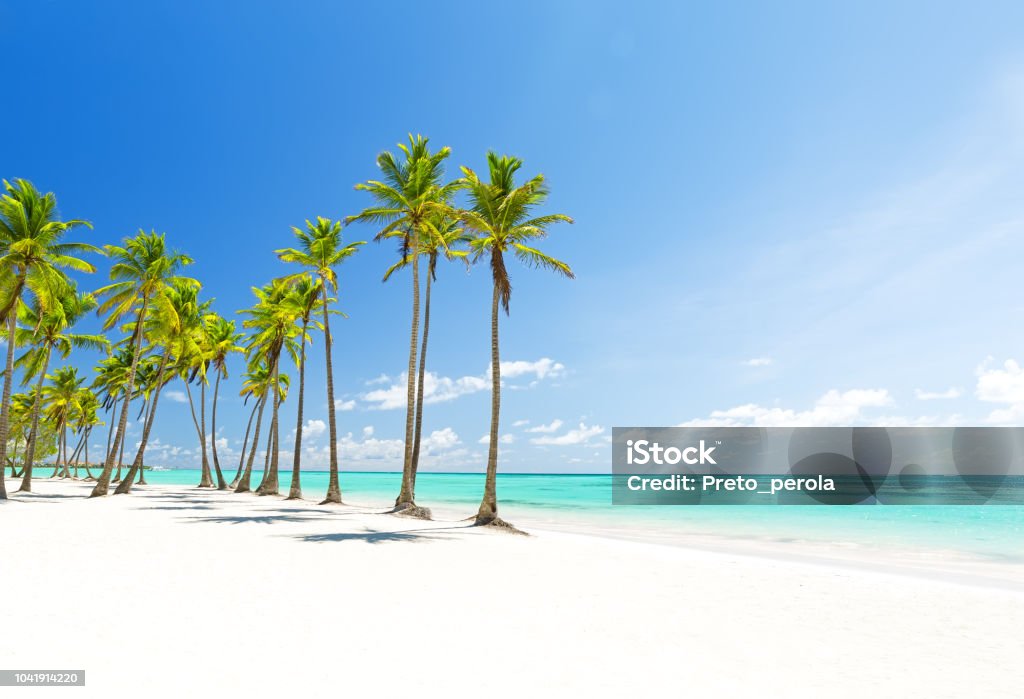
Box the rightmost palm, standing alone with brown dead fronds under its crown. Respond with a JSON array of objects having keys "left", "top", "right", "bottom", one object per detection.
[{"left": 460, "top": 152, "right": 573, "bottom": 525}]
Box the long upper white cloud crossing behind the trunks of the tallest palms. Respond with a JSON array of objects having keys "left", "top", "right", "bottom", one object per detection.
[{"left": 361, "top": 357, "right": 565, "bottom": 410}]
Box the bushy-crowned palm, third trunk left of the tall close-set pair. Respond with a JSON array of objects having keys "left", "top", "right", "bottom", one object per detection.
[{"left": 241, "top": 279, "right": 301, "bottom": 495}]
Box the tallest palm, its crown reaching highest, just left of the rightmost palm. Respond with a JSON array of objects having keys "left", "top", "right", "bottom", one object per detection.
[{"left": 345, "top": 134, "right": 461, "bottom": 517}]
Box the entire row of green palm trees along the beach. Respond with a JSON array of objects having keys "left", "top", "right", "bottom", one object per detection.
[{"left": 0, "top": 135, "right": 572, "bottom": 525}]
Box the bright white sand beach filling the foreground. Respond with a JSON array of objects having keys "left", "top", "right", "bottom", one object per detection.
[{"left": 0, "top": 480, "right": 1024, "bottom": 697}]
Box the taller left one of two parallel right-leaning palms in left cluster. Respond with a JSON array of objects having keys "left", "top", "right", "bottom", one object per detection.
[{"left": 90, "top": 230, "right": 200, "bottom": 497}]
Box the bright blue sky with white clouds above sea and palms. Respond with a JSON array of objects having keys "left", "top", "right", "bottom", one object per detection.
[{"left": 0, "top": 0, "right": 1024, "bottom": 472}]
